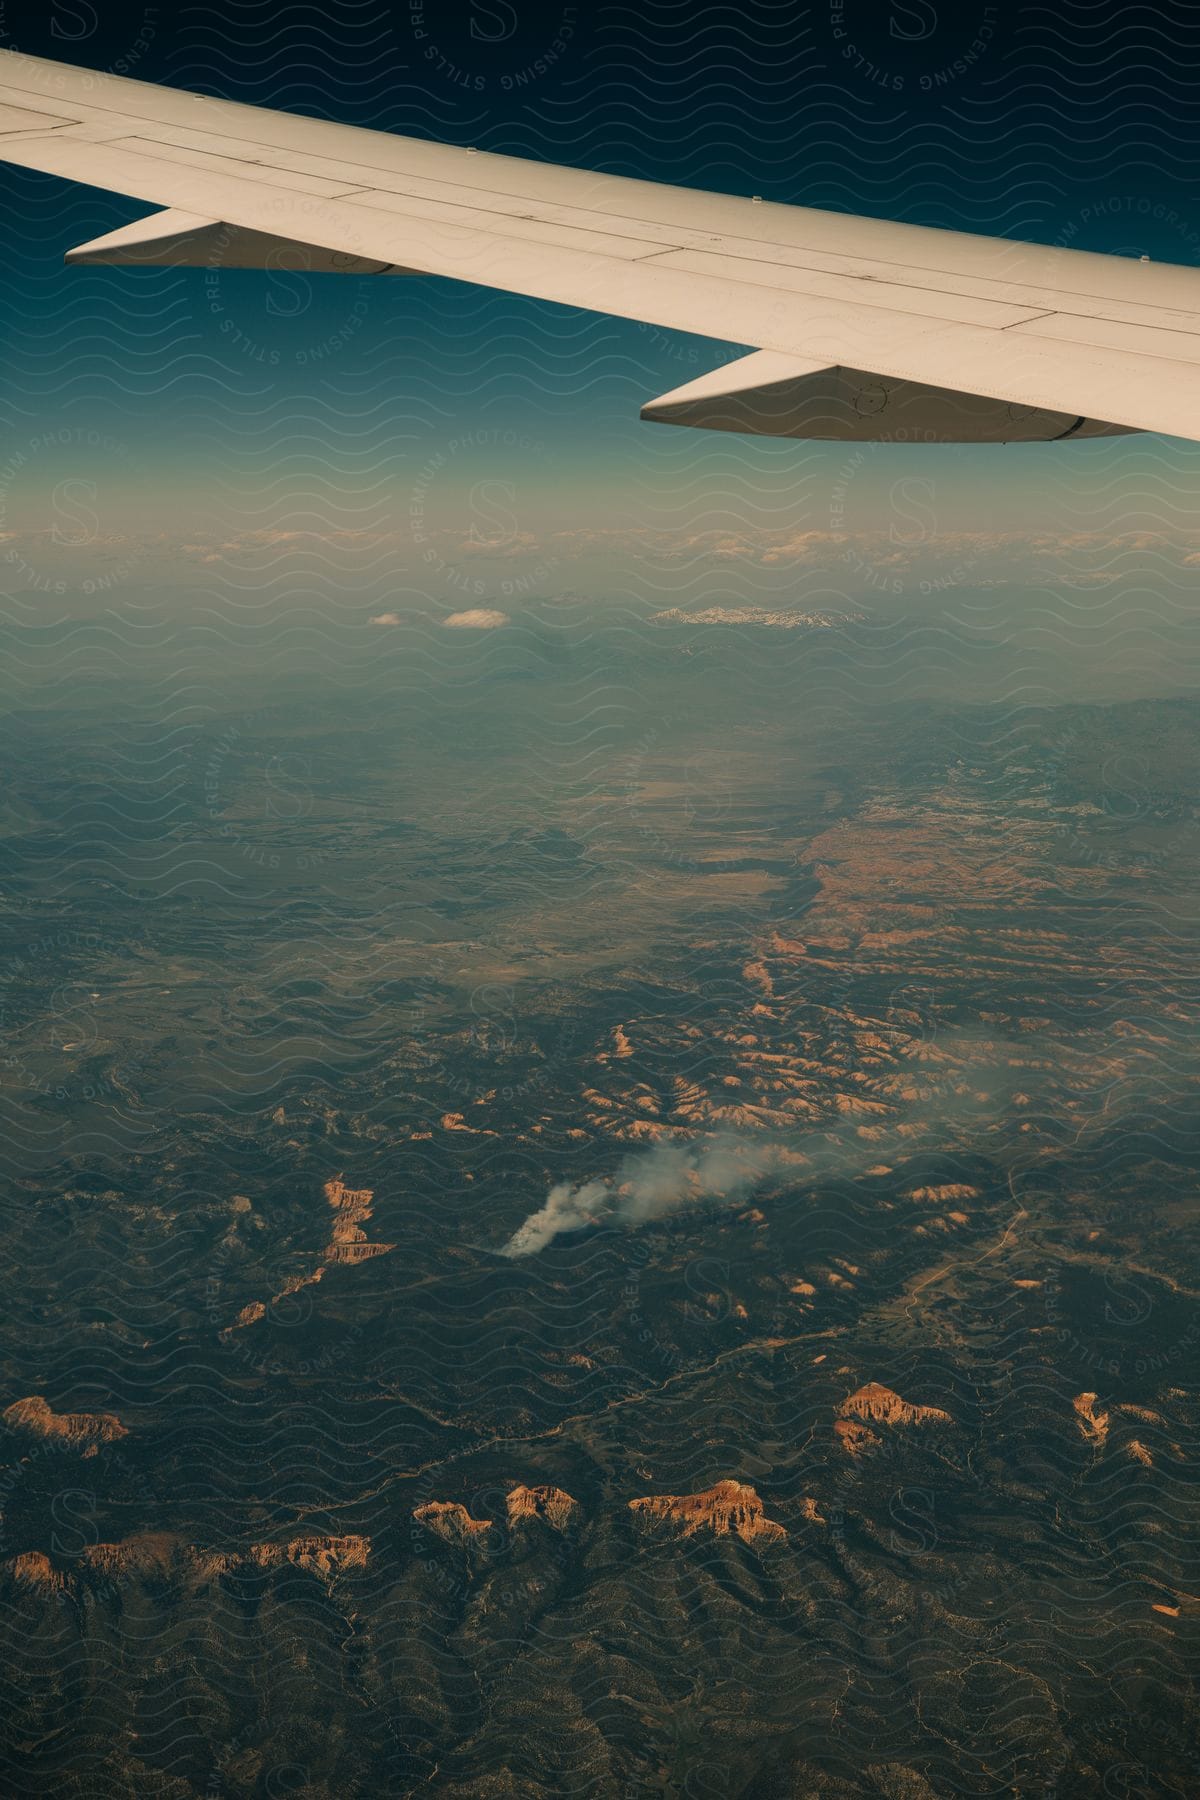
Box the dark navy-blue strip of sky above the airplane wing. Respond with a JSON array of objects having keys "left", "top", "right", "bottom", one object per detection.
[{"left": 0, "top": 0, "right": 1200, "bottom": 239}]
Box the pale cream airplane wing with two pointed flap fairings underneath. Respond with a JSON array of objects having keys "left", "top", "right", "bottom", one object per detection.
[{"left": 0, "top": 50, "right": 1200, "bottom": 443}]
